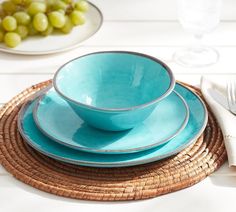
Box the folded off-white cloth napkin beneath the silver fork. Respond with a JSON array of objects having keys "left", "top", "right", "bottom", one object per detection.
[{"left": 201, "top": 77, "right": 236, "bottom": 166}]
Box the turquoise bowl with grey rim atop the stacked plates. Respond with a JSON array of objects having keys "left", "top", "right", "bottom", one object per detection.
[{"left": 53, "top": 51, "right": 175, "bottom": 131}]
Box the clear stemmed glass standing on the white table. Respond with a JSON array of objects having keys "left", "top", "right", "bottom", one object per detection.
[{"left": 173, "top": 0, "right": 222, "bottom": 67}]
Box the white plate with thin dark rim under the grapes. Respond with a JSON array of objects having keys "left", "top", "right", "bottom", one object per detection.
[{"left": 0, "top": 2, "right": 103, "bottom": 55}]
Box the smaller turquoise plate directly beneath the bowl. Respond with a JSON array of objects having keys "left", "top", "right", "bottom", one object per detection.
[{"left": 33, "top": 88, "right": 189, "bottom": 154}]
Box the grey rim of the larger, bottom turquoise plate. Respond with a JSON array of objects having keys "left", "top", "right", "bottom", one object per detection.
[{"left": 17, "top": 82, "right": 208, "bottom": 168}]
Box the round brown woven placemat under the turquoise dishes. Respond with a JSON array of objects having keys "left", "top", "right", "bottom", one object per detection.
[{"left": 0, "top": 81, "right": 226, "bottom": 201}]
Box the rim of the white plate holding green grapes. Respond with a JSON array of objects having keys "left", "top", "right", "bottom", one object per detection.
[{"left": 0, "top": 1, "right": 104, "bottom": 56}]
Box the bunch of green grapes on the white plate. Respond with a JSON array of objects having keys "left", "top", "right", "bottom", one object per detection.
[{"left": 0, "top": 0, "right": 89, "bottom": 48}]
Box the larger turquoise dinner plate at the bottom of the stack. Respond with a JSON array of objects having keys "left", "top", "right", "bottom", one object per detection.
[{"left": 18, "top": 84, "right": 207, "bottom": 167}]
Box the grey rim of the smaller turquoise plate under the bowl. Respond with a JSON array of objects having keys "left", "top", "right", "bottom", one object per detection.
[{"left": 33, "top": 85, "right": 189, "bottom": 154}]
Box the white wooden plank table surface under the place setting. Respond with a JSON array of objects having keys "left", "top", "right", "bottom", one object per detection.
[{"left": 0, "top": 0, "right": 236, "bottom": 212}]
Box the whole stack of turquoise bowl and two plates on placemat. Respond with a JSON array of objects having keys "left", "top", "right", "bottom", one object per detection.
[{"left": 18, "top": 51, "right": 207, "bottom": 167}]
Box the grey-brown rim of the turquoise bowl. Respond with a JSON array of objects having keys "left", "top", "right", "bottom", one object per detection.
[{"left": 52, "top": 51, "right": 175, "bottom": 112}]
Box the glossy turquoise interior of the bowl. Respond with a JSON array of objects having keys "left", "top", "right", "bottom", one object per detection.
[{"left": 55, "top": 52, "right": 171, "bottom": 109}]
